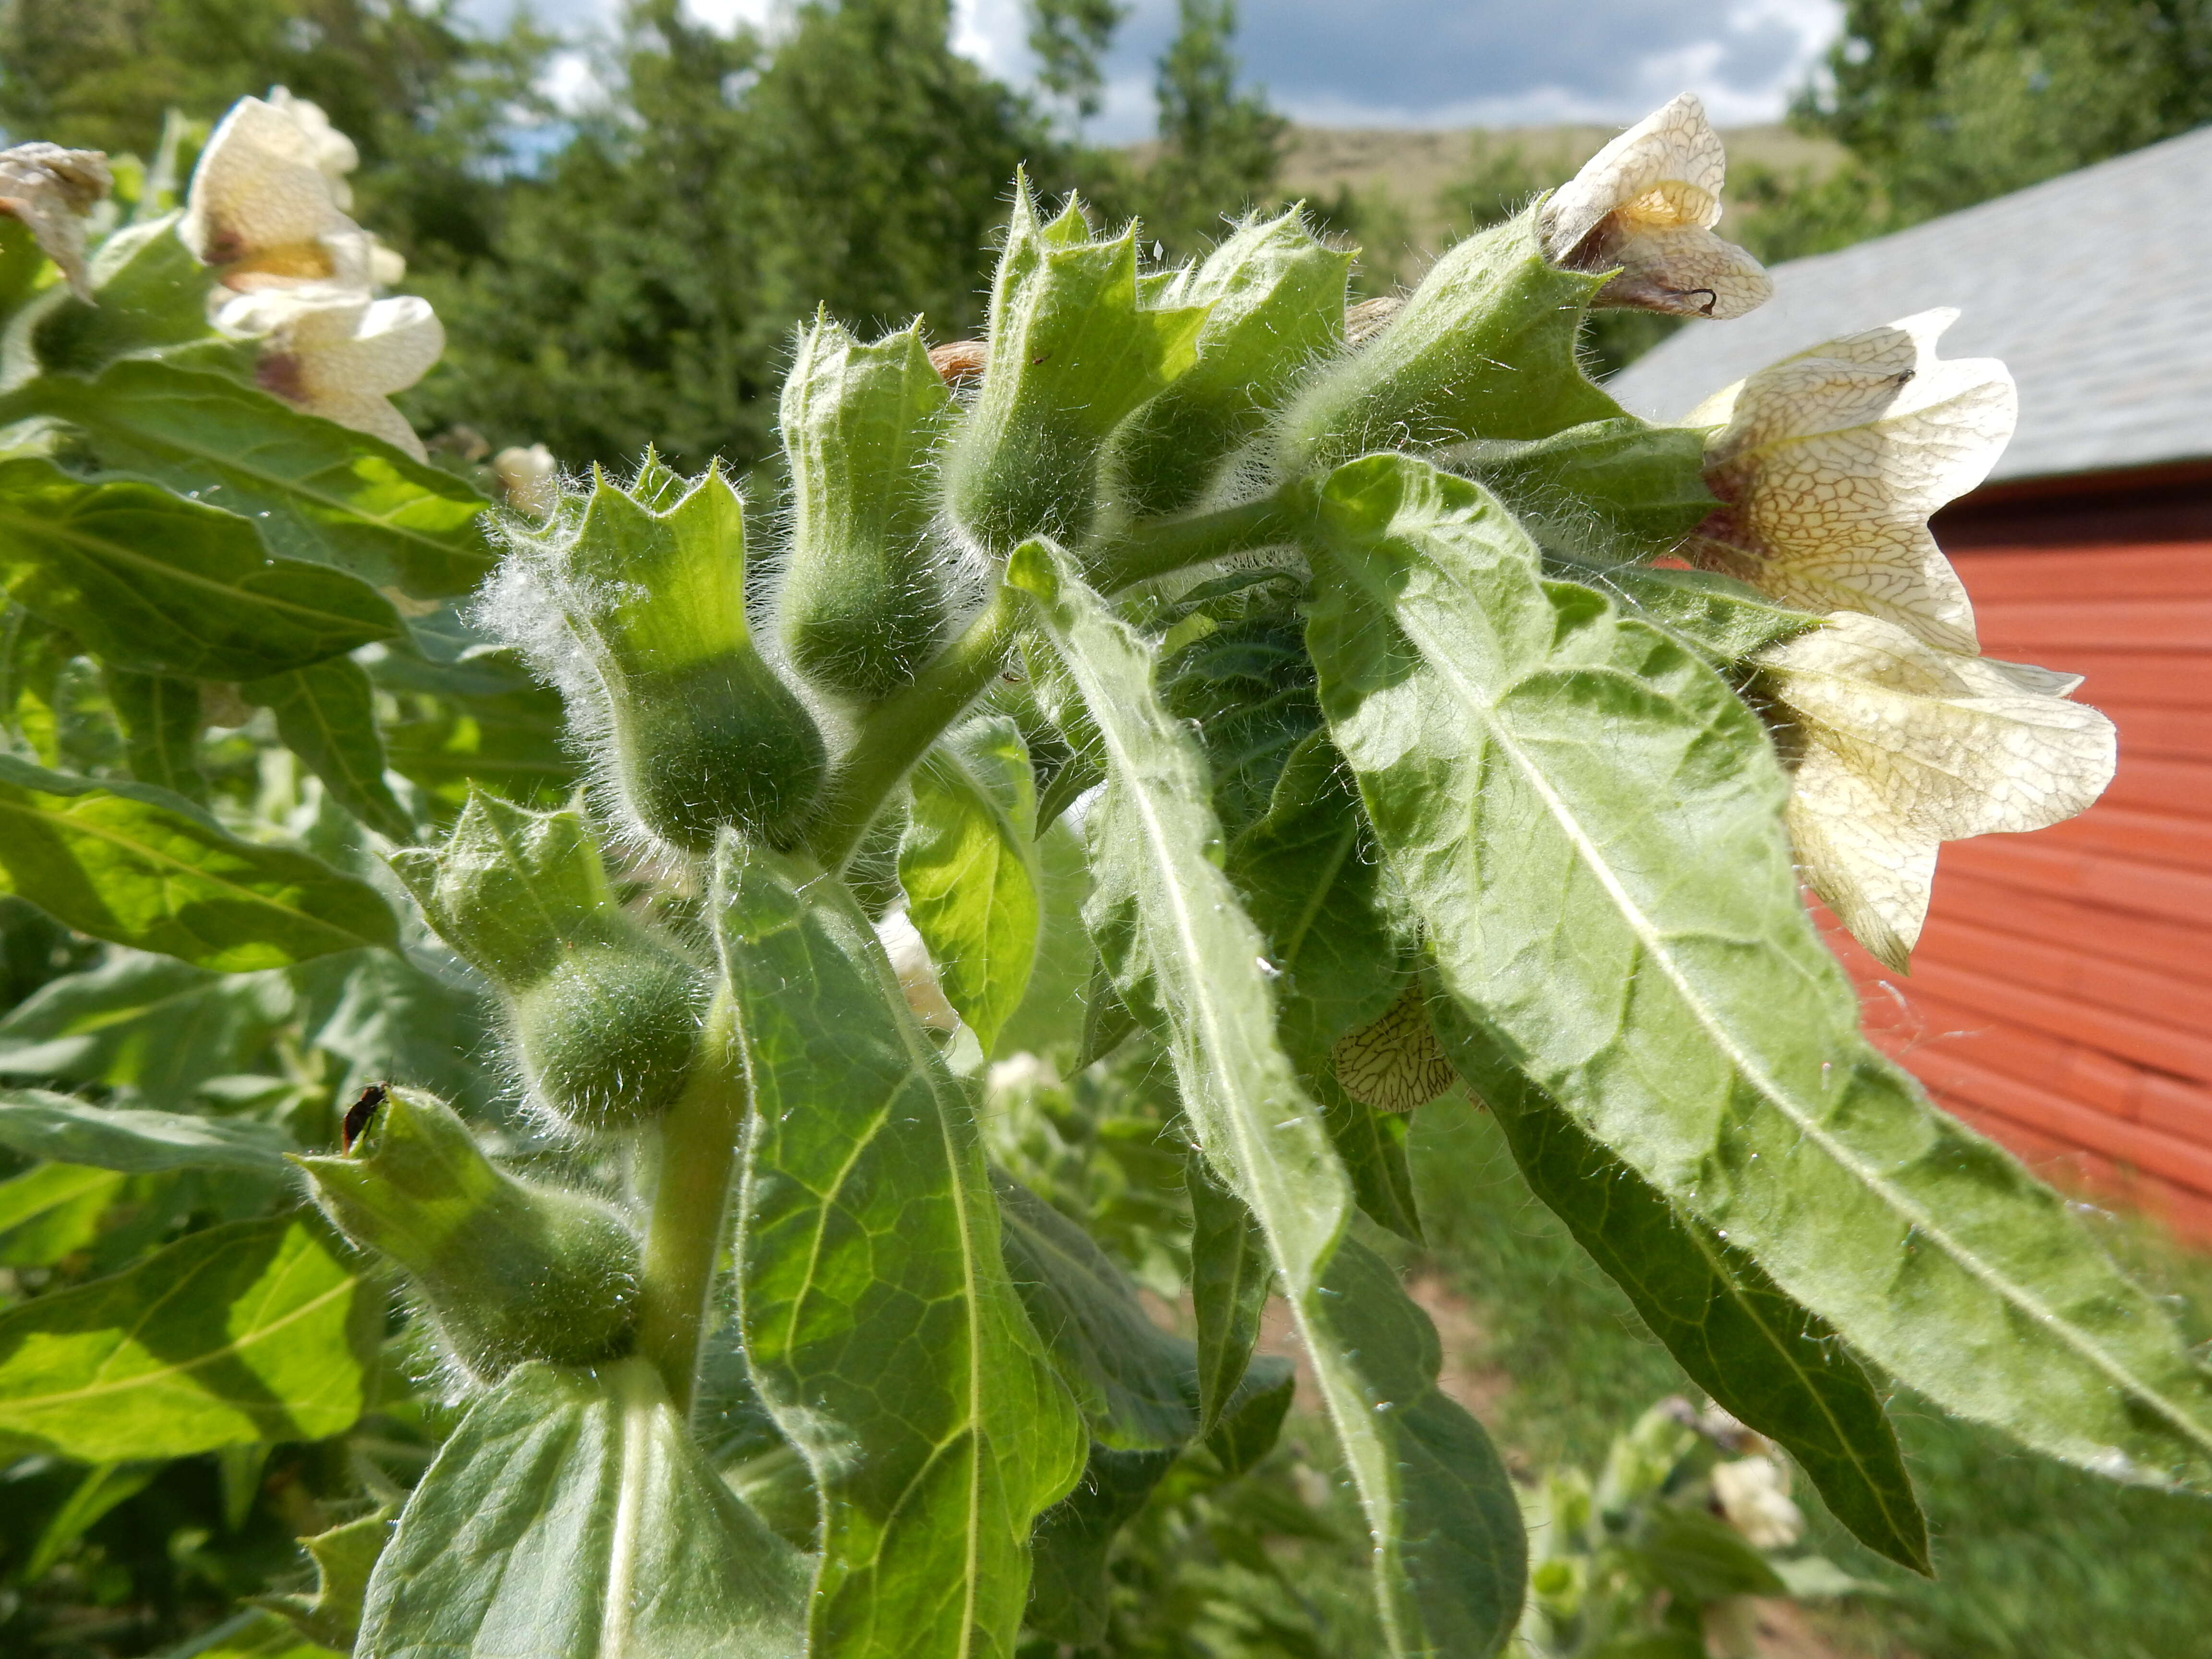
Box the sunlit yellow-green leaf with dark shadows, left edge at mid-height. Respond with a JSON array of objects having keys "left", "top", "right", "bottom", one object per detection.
[{"left": 0, "top": 754, "right": 398, "bottom": 974}]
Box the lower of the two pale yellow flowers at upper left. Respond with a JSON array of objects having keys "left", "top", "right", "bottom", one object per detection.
[{"left": 215, "top": 283, "right": 445, "bottom": 460}]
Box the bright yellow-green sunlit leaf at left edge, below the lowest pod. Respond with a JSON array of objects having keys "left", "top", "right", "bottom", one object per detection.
[{"left": 0, "top": 1216, "right": 385, "bottom": 1462}]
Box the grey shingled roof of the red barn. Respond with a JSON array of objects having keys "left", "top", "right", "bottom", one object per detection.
[{"left": 1611, "top": 126, "right": 2212, "bottom": 478}]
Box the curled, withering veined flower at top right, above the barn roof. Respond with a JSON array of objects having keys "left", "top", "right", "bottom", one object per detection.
[{"left": 1538, "top": 93, "right": 1774, "bottom": 316}]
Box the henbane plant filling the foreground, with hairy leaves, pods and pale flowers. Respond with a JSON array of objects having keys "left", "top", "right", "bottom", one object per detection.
[{"left": 0, "top": 88, "right": 2185, "bottom": 1659}]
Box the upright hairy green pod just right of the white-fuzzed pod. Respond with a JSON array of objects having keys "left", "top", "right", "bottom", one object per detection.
[{"left": 779, "top": 316, "right": 953, "bottom": 699}]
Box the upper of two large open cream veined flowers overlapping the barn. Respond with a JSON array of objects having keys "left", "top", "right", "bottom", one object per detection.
[{"left": 1683, "top": 310, "right": 2020, "bottom": 655}]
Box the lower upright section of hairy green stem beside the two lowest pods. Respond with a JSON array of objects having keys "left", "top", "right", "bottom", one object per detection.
[{"left": 637, "top": 991, "right": 745, "bottom": 1414}]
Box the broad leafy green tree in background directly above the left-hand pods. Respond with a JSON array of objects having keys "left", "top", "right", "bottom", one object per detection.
[{"left": 416, "top": 0, "right": 1073, "bottom": 467}]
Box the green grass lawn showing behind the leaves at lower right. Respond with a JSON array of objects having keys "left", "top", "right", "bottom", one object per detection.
[{"left": 1414, "top": 1104, "right": 2212, "bottom": 1659}]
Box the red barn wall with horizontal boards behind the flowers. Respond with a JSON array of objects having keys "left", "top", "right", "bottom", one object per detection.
[{"left": 1831, "top": 467, "right": 2212, "bottom": 1243}]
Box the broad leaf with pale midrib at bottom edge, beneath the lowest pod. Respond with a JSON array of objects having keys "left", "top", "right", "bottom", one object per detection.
[{"left": 354, "top": 1360, "right": 805, "bottom": 1659}]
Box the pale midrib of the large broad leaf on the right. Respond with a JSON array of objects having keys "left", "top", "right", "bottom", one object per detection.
[{"left": 1396, "top": 606, "right": 2212, "bottom": 1447}]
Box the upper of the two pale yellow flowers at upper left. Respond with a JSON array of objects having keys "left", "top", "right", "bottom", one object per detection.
[{"left": 177, "top": 88, "right": 407, "bottom": 292}]
